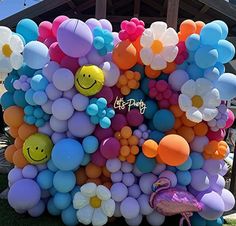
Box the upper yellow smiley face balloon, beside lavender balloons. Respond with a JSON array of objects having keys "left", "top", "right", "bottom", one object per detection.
[{"left": 75, "top": 65, "right": 104, "bottom": 96}]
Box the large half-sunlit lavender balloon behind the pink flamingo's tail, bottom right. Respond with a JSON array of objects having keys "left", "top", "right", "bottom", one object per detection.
[{"left": 197, "top": 191, "right": 225, "bottom": 220}]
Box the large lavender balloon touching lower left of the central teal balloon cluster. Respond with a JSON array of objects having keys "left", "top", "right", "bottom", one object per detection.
[{"left": 68, "top": 112, "right": 95, "bottom": 138}]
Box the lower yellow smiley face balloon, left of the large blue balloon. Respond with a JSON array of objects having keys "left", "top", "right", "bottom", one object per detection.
[{"left": 23, "top": 133, "right": 53, "bottom": 165}]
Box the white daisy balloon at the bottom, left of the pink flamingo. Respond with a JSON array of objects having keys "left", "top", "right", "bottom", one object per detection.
[{"left": 73, "top": 183, "right": 115, "bottom": 226}]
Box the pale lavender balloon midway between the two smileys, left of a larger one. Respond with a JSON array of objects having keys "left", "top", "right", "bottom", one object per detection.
[{"left": 52, "top": 98, "right": 74, "bottom": 120}]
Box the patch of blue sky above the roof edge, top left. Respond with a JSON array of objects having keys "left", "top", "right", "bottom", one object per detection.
[{"left": 0, "top": 0, "right": 40, "bottom": 20}]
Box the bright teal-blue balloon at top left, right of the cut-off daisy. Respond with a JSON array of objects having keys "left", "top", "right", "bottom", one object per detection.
[{"left": 16, "top": 19, "right": 39, "bottom": 43}]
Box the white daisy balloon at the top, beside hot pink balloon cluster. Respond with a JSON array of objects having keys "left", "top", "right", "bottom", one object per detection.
[{"left": 140, "top": 21, "right": 179, "bottom": 70}]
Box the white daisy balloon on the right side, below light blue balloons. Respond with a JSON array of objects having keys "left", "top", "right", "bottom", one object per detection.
[{"left": 179, "top": 78, "right": 221, "bottom": 123}]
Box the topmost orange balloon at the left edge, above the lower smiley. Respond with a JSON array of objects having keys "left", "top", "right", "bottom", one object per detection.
[{"left": 3, "top": 106, "right": 24, "bottom": 127}]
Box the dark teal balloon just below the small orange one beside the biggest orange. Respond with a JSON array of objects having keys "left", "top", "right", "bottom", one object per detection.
[{"left": 135, "top": 153, "right": 156, "bottom": 173}]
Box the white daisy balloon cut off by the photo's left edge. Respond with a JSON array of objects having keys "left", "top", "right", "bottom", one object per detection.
[{"left": 0, "top": 26, "right": 24, "bottom": 74}]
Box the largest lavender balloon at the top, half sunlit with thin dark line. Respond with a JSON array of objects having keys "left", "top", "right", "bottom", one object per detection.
[{"left": 57, "top": 19, "right": 93, "bottom": 58}]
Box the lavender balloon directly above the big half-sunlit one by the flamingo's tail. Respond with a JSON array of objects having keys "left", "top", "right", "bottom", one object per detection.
[{"left": 190, "top": 169, "right": 210, "bottom": 191}]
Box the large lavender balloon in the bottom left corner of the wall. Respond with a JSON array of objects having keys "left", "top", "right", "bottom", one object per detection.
[{"left": 8, "top": 179, "right": 41, "bottom": 210}]
